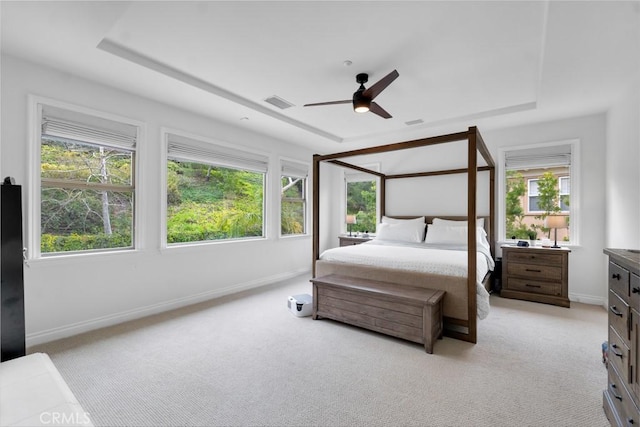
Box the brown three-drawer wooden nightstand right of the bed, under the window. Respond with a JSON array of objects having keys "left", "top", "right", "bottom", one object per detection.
[{"left": 500, "top": 246, "right": 571, "bottom": 307}]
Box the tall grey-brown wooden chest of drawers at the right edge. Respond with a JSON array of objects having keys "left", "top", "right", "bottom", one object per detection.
[{"left": 603, "top": 249, "right": 640, "bottom": 426}]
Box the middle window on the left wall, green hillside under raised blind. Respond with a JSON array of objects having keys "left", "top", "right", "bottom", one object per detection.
[{"left": 166, "top": 134, "right": 268, "bottom": 244}]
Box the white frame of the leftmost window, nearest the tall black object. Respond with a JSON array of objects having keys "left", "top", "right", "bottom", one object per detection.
[{"left": 25, "top": 94, "right": 146, "bottom": 262}]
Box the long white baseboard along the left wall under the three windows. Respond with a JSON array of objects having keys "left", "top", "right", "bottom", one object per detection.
[{"left": 26, "top": 268, "right": 311, "bottom": 347}]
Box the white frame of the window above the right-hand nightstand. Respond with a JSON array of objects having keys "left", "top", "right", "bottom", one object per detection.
[{"left": 497, "top": 139, "right": 581, "bottom": 247}]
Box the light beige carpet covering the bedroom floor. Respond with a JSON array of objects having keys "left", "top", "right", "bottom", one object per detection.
[{"left": 29, "top": 276, "right": 608, "bottom": 426}]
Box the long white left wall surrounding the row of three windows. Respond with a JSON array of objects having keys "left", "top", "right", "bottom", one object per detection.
[{"left": 0, "top": 56, "right": 312, "bottom": 345}]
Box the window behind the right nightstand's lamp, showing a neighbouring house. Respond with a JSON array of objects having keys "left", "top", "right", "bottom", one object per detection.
[{"left": 501, "top": 141, "right": 577, "bottom": 244}]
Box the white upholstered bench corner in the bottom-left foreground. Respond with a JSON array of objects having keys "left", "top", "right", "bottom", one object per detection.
[{"left": 0, "top": 353, "right": 93, "bottom": 426}]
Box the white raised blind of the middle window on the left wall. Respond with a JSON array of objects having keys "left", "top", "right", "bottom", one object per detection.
[{"left": 167, "top": 134, "right": 269, "bottom": 173}]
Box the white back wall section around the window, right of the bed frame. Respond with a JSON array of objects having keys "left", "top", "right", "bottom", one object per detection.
[{"left": 482, "top": 114, "right": 608, "bottom": 305}]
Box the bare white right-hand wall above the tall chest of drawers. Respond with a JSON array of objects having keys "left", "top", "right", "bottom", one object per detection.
[{"left": 605, "top": 78, "right": 640, "bottom": 249}]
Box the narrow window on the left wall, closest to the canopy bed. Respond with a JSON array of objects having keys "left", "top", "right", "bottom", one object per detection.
[{"left": 280, "top": 160, "right": 308, "bottom": 236}]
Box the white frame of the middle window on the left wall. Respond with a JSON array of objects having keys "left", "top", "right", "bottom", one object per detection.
[{"left": 160, "top": 127, "right": 270, "bottom": 250}]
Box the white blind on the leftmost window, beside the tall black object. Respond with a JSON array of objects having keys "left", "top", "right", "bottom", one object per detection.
[{"left": 42, "top": 105, "right": 138, "bottom": 149}]
